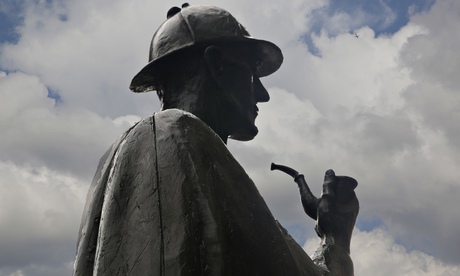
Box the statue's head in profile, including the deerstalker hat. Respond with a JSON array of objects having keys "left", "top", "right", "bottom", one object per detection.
[{"left": 130, "top": 6, "right": 283, "bottom": 141}]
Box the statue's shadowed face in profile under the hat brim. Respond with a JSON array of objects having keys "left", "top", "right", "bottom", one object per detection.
[{"left": 219, "top": 58, "right": 270, "bottom": 141}]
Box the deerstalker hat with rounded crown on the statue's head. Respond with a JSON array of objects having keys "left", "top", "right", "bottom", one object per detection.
[{"left": 129, "top": 6, "right": 283, "bottom": 92}]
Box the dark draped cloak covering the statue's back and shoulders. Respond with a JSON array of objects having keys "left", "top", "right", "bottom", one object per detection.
[{"left": 74, "top": 109, "right": 320, "bottom": 276}]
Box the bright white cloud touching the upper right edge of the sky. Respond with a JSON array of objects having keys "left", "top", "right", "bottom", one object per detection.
[{"left": 401, "top": 0, "right": 460, "bottom": 154}]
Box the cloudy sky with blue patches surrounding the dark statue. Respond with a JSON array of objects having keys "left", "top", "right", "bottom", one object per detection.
[{"left": 0, "top": 0, "right": 460, "bottom": 276}]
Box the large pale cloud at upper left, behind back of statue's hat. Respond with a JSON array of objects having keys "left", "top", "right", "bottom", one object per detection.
[{"left": 0, "top": 1, "right": 161, "bottom": 117}]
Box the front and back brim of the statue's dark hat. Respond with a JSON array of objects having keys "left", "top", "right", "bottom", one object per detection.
[{"left": 129, "top": 37, "right": 283, "bottom": 93}]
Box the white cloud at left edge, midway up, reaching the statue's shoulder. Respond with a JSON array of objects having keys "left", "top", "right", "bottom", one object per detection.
[{"left": 0, "top": 72, "right": 135, "bottom": 177}]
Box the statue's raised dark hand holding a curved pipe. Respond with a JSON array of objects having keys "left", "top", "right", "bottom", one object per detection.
[{"left": 271, "top": 163, "right": 359, "bottom": 276}]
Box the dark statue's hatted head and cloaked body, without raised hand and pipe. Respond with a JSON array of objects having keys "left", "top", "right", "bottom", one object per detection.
[{"left": 74, "top": 6, "right": 320, "bottom": 276}]
